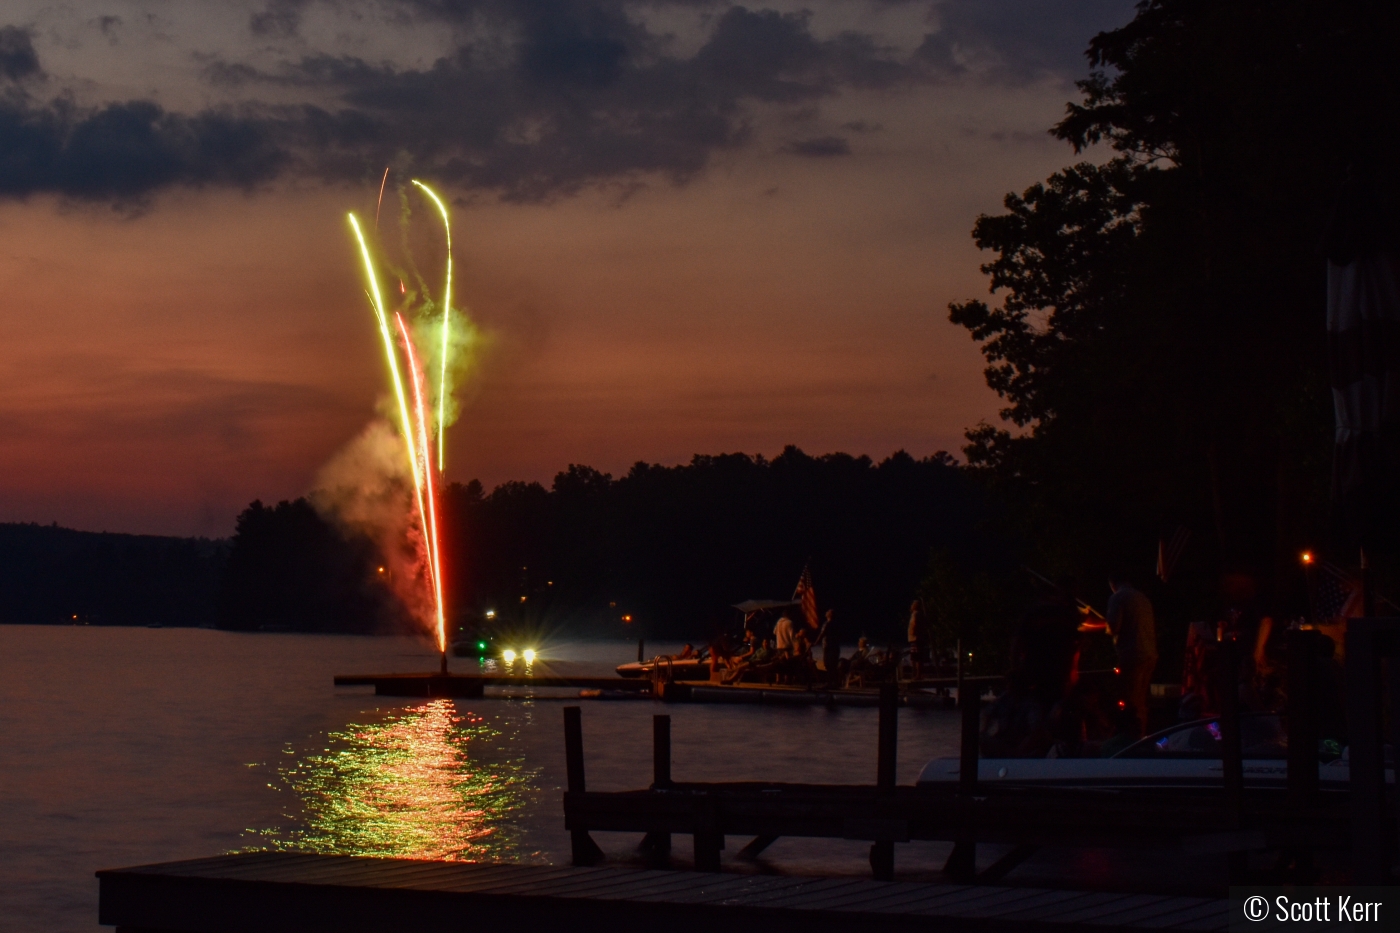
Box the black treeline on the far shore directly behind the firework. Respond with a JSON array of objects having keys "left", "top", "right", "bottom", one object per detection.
[{"left": 210, "top": 447, "right": 1005, "bottom": 637}]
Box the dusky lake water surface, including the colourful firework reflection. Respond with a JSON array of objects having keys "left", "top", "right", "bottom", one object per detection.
[{"left": 0, "top": 626, "right": 958, "bottom": 933}]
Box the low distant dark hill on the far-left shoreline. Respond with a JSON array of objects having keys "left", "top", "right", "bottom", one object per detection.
[{"left": 0, "top": 524, "right": 230, "bottom": 625}]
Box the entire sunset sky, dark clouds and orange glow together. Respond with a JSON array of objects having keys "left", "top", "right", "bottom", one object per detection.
[{"left": 0, "top": 0, "right": 1133, "bottom": 535}]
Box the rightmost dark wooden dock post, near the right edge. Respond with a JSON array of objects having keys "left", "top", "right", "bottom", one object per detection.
[{"left": 1347, "top": 619, "right": 1390, "bottom": 884}]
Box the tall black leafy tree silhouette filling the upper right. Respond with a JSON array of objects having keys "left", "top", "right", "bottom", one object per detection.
[{"left": 949, "top": 0, "right": 1400, "bottom": 624}]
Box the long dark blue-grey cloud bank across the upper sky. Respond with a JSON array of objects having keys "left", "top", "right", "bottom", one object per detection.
[{"left": 0, "top": 0, "right": 921, "bottom": 200}]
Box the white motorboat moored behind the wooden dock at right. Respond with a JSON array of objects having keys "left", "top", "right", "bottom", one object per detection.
[{"left": 917, "top": 713, "right": 1377, "bottom": 790}]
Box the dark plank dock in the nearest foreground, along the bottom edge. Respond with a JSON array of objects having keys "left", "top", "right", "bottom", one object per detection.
[{"left": 97, "top": 852, "right": 1229, "bottom": 933}]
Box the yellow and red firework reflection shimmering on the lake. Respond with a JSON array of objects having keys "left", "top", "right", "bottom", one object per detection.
[{"left": 259, "top": 699, "right": 533, "bottom": 862}]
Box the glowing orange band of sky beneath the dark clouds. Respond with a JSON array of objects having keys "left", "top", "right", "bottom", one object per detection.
[{"left": 0, "top": 1, "right": 1125, "bottom": 535}]
